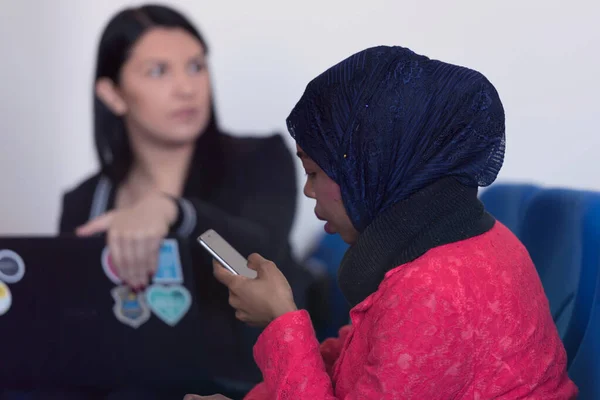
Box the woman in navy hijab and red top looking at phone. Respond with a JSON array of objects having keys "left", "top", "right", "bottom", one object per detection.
[{"left": 188, "top": 47, "right": 577, "bottom": 400}]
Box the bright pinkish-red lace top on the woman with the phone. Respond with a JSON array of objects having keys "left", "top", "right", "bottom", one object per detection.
[{"left": 246, "top": 223, "right": 577, "bottom": 400}]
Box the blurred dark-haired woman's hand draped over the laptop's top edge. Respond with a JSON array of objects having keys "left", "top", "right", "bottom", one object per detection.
[{"left": 76, "top": 191, "right": 177, "bottom": 289}]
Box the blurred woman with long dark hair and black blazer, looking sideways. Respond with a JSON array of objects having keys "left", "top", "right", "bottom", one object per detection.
[{"left": 60, "top": 5, "right": 311, "bottom": 396}]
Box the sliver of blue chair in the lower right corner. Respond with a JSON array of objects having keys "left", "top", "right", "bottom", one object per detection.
[{"left": 569, "top": 268, "right": 600, "bottom": 400}]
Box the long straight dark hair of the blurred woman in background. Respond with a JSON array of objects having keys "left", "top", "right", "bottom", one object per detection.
[{"left": 94, "top": 5, "right": 219, "bottom": 182}]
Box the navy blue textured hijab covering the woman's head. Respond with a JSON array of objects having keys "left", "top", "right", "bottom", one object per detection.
[{"left": 287, "top": 46, "right": 505, "bottom": 232}]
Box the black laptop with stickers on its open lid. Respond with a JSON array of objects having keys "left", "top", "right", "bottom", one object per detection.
[{"left": 0, "top": 237, "right": 210, "bottom": 390}]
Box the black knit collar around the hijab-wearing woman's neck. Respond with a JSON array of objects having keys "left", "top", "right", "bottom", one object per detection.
[{"left": 338, "top": 178, "right": 495, "bottom": 307}]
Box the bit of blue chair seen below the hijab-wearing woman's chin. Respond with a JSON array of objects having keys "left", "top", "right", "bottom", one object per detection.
[{"left": 304, "top": 234, "right": 350, "bottom": 340}]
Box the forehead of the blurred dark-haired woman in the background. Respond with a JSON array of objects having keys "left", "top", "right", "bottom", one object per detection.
[{"left": 130, "top": 28, "right": 204, "bottom": 62}]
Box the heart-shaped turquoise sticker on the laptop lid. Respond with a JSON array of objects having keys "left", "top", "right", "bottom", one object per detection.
[{"left": 146, "top": 285, "right": 192, "bottom": 326}]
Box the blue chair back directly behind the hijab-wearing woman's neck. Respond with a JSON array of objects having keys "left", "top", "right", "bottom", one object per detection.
[{"left": 479, "top": 183, "right": 541, "bottom": 238}]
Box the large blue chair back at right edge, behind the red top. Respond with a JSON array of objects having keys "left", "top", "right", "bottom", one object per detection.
[{"left": 520, "top": 189, "right": 600, "bottom": 364}]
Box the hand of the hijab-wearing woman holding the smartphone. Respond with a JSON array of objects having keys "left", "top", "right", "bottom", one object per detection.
[{"left": 213, "top": 254, "right": 297, "bottom": 326}]
